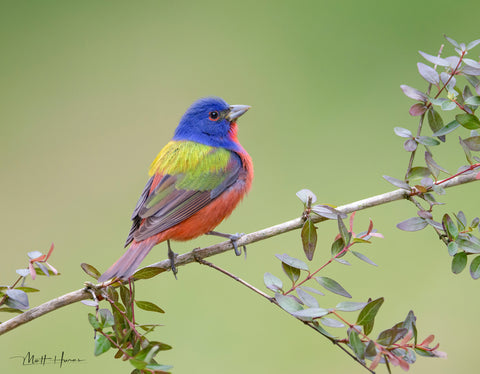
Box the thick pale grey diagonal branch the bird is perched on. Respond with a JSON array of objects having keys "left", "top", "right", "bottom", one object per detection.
[{"left": 0, "top": 172, "right": 478, "bottom": 335}]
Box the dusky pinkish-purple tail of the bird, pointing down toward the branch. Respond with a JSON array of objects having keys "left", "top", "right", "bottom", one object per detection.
[{"left": 98, "top": 239, "right": 156, "bottom": 282}]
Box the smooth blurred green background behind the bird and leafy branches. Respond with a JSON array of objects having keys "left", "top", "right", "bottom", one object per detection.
[{"left": 0, "top": 0, "right": 480, "bottom": 374}]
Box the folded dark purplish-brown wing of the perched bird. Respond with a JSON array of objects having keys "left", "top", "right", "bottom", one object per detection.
[{"left": 127, "top": 152, "right": 242, "bottom": 244}]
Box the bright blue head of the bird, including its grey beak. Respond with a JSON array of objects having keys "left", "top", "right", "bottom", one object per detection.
[{"left": 173, "top": 97, "right": 250, "bottom": 151}]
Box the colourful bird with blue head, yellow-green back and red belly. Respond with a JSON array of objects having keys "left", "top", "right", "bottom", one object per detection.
[{"left": 98, "top": 97, "right": 254, "bottom": 282}]
